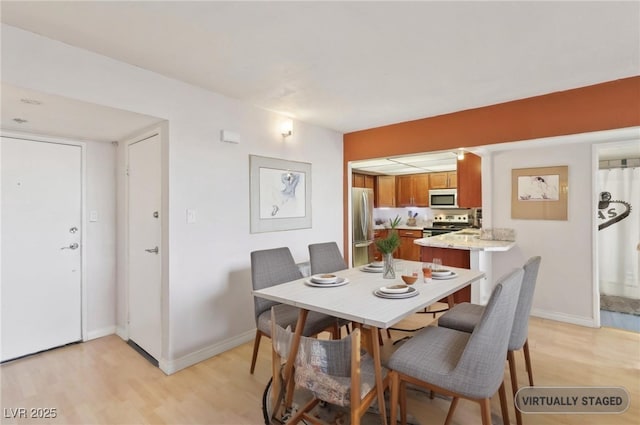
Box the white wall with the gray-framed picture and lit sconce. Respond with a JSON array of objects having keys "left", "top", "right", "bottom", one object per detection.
[{"left": 2, "top": 25, "right": 343, "bottom": 371}]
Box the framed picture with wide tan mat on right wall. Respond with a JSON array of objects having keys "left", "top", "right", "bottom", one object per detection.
[{"left": 511, "top": 165, "right": 569, "bottom": 220}]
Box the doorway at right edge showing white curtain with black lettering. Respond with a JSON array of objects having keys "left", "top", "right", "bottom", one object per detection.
[{"left": 596, "top": 141, "right": 640, "bottom": 332}]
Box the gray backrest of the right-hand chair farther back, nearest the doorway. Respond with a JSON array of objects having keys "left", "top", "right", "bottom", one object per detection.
[{"left": 509, "top": 256, "right": 542, "bottom": 350}]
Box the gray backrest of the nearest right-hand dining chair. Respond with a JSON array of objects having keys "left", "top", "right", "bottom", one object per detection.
[{"left": 452, "top": 268, "right": 524, "bottom": 398}]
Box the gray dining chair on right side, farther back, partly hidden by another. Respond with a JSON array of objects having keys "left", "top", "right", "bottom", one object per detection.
[{"left": 438, "top": 256, "right": 542, "bottom": 425}]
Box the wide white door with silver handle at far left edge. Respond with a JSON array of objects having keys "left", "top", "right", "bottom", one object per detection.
[{"left": 0, "top": 137, "right": 82, "bottom": 361}]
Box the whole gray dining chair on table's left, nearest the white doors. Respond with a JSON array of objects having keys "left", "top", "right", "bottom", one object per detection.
[{"left": 251, "top": 247, "right": 338, "bottom": 373}]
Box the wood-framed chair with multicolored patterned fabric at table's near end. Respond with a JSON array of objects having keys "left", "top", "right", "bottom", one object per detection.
[{"left": 271, "top": 306, "right": 388, "bottom": 425}]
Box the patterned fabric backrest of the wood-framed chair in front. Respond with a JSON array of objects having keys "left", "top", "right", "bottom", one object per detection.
[{"left": 271, "top": 306, "right": 360, "bottom": 406}]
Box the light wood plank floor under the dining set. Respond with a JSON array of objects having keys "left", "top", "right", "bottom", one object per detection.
[{"left": 0, "top": 315, "right": 640, "bottom": 425}]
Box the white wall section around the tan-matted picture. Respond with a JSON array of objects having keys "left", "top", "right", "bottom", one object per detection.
[{"left": 491, "top": 143, "right": 594, "bottom": 326}]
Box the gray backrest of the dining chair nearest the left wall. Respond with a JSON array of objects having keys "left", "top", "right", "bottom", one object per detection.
[{"left": 251, "top": 247, "right": 303, "bottom": 320}]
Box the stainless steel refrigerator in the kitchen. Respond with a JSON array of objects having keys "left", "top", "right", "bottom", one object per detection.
[{"left": 351, "top": 188, "right": 373, "bottom": 267}]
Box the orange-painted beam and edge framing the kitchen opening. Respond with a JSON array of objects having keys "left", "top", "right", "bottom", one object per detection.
[{"left": 343, "top": 76, "right": 640, "bottom": 262}]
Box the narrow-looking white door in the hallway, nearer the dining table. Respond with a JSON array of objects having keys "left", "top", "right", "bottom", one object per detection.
[{"left": 128, "top": 135, "right": 162, "bottom": 360}]
